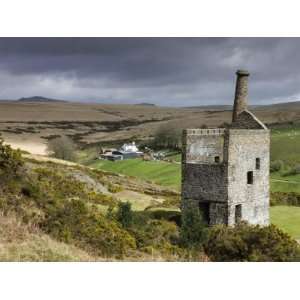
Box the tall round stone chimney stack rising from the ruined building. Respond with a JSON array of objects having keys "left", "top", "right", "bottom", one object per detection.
[{"left": 232, "top": 70, "right": 250, "bottom": 122}]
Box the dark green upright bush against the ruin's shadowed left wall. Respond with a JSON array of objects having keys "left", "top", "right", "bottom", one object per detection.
[{"left": 180, "top": 204, "right": 207, "bottom": 248}]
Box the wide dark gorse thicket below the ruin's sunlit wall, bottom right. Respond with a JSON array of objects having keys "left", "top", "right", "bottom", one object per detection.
[{"left": 204, "top": 223, "right": 300, "bottom": 261}]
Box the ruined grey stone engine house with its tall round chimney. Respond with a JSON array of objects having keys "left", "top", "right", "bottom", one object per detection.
[{"left": 182, "top": 70, "right": 270, "bottom": 225}]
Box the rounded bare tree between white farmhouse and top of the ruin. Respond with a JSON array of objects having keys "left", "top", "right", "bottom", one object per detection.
[{"left": 153, "top": 123, "right": 182, "bottom": 149}]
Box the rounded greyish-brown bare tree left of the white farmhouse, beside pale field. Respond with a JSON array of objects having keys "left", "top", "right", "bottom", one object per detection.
[{"left": 48, "top": 136, "right": 76, "bottom": 161}]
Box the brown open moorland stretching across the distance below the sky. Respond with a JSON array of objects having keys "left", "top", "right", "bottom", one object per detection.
[{"left": 0, "top": 101, "right": 300, "bottom": 154}]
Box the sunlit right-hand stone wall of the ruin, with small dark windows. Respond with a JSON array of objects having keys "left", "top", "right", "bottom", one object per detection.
[{"left": 227, "top": 129, "right": 270, "bottom": 225}]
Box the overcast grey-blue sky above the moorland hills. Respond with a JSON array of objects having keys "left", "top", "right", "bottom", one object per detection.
[{"left": 0, "top": 38, "right": 300, "bottom": 106}]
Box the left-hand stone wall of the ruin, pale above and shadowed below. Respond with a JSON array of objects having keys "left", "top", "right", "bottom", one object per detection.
[{"left": 182, "top": 128, "right": 228, "bottom": 225}]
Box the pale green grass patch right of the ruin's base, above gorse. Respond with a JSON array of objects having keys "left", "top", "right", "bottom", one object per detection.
[{"left": 270, "top": 206, "right": 300, "bottom": 239}]
